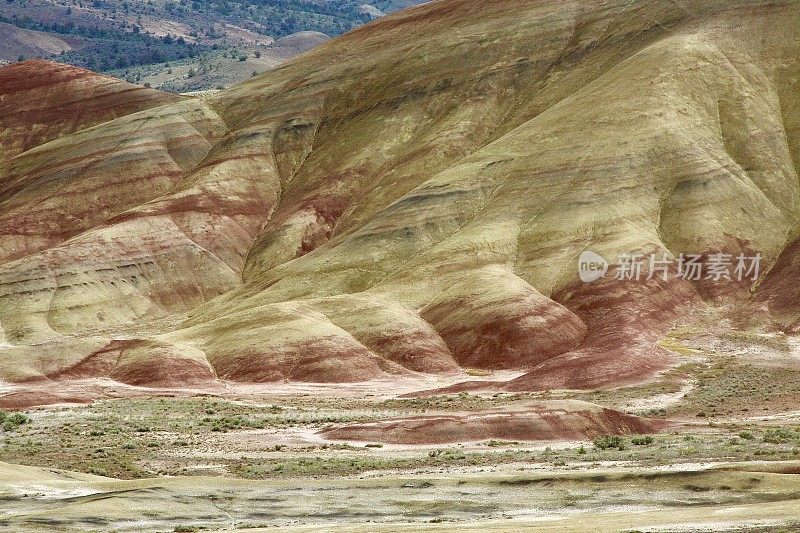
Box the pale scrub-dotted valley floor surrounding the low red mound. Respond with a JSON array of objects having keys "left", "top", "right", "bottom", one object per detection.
[{"left": 0, "top": 332, "right": 800, "bottom": 531}]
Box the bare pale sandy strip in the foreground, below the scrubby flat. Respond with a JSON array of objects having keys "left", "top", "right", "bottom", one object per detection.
[{"left": 0, "top": 463, "right": 800, "bottom": 531}]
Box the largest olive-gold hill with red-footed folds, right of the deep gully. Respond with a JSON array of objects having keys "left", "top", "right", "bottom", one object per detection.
[{"left": 181, "top": 2, "right": 800, "bottom": 388}]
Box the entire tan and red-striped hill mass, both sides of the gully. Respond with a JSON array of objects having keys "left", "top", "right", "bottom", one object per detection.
[{"left": 0, "top": 0, "right": 800, "bottom": 389}]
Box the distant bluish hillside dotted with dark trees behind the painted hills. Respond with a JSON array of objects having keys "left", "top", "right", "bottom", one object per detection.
[{"left": 0, "top": 0, "right": 428, "bottom": 76}]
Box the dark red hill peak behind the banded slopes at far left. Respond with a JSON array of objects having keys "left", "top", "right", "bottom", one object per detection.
[{"left": 0, "top": 60, "right": 180, "bottom": 161}]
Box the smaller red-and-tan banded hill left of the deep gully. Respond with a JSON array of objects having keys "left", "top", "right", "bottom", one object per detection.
[{"left": 0, "top": 67, "right": 276, "bottom": 383}]
